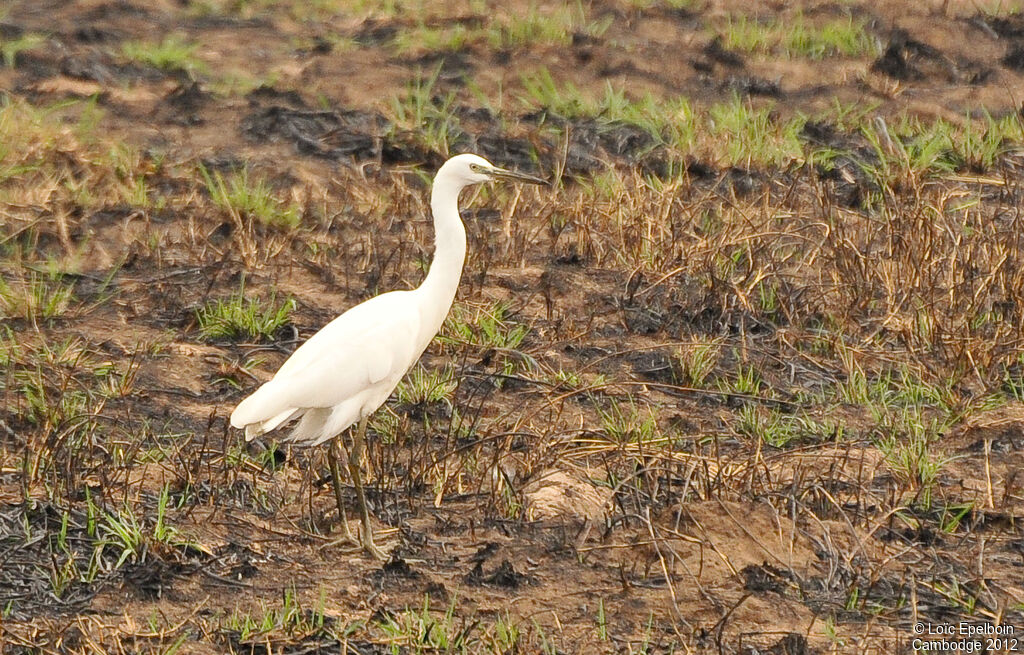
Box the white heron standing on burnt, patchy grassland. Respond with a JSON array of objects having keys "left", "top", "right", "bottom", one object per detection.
[{"left": 231, "top": 155, "right": 547, "bottom": 558}]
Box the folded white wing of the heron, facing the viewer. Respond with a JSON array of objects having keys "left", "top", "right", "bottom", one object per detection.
[{"left": 231, "top": 292, "right": 419, "bottom": 428}]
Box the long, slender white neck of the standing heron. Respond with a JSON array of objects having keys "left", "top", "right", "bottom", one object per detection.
[{"left": 420, "top": 179, "right": 466, "bottom": 347}]
